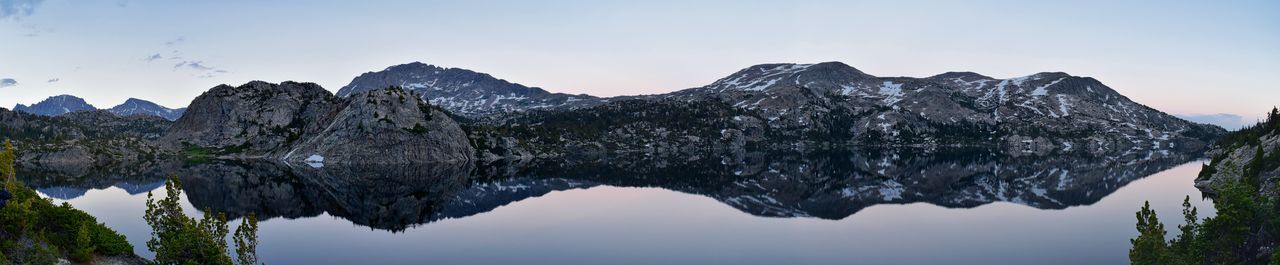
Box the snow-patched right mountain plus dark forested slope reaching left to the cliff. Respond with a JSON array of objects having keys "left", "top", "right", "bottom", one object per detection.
[{"left": 453, "top": 61, "right": 1225, "bottom": 154}]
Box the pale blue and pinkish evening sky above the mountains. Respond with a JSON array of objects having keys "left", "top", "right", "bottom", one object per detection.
[{"left": 0, "top": 0, "right": 1280, "bottom": 119}]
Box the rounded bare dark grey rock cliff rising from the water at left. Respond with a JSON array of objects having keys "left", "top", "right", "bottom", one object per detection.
[{"left": 163, "top": 81, "right": 474, "bottom": 164}]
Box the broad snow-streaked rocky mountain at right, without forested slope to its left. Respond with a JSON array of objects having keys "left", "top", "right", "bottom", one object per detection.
[{"left": 654, "top": 63, "right": 1224, "bottom": 151}]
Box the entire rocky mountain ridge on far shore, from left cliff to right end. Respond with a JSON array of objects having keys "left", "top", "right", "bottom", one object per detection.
[{"left": 10, "top": 61, "right": 1225, "bottom": 163}]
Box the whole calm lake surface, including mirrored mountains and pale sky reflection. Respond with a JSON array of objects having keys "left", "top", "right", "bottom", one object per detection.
[{"left": 22, "top": 151, "right": 1213, "bottom": 264}]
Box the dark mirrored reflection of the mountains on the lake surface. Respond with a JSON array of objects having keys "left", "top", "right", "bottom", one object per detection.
[{"left": 20, "top": 147, "right": 1197, "bottom": 232}]
